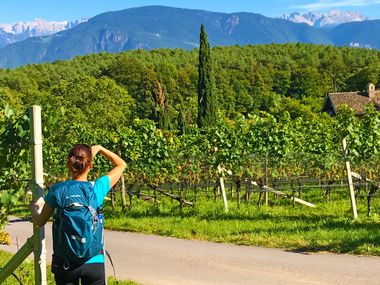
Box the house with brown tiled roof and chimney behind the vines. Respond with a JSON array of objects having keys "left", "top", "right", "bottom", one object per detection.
[{"left": 322, "top": 83, "right": 380, "bottom": 116}]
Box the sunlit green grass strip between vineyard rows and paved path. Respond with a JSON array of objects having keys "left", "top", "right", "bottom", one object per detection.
[{"left": 101, "top": 186, "right": 380, "bottom": 256}]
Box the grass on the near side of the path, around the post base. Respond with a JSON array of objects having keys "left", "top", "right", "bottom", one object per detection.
[{"left": 0, "top": 250, "right": 138, "bottom": 285}]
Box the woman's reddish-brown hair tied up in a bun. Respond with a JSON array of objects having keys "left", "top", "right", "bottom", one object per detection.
[{"left": 67, "top": 144, "right": 92, "bottom": 177}]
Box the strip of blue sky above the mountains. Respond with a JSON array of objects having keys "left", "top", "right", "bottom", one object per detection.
[{"left": 0, "top": 0, "right": 380, "bottom": 23}]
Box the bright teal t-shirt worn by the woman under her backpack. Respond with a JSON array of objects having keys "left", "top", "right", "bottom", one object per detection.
[{"left": 45, "top": 175, "right": 111, "bottom": 263}]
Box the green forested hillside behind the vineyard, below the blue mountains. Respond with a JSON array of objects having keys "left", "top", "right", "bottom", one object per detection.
[{"left": 0, "top": 44, "right": 380, "bottom": 127}]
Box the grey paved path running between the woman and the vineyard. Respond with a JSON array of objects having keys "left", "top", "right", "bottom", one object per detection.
[{"left": 0, "top": 216, "right": 380, "bottom": 285}]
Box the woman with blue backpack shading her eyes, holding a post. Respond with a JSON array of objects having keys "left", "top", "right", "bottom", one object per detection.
[{"left": 30, "top": 144, "right": 125, "bottom": 285}]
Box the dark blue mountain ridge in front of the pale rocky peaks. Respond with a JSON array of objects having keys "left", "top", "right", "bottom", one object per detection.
[{"left": 0, "top": 6, "right": 380, "bottom": 68}]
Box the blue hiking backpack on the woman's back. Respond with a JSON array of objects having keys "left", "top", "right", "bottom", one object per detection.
[{"left": 53, "top": 181, "right": 103, "bottom": 265}]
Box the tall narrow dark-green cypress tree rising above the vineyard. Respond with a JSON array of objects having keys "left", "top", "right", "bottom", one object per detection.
[{"left": 197, "top": 25, "right": 217, "bottom": 128}]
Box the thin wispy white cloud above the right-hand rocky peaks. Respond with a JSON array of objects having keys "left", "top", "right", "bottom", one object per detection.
[{"left": 293, "top": 0, "right": 380, "bottom": 11}]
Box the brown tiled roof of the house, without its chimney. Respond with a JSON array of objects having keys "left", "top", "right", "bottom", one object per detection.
[{"left": 329, "top": 92, "right": 371, "bottom": 114}]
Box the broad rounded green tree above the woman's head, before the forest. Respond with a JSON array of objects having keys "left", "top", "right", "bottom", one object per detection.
[{"left": 43, "top": 76, "right": 135, "bottom": 132}]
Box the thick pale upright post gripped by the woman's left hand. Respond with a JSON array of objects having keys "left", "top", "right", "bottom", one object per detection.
[{"left": 29, "top": 106, "right": 47, "bottom": 285}]
